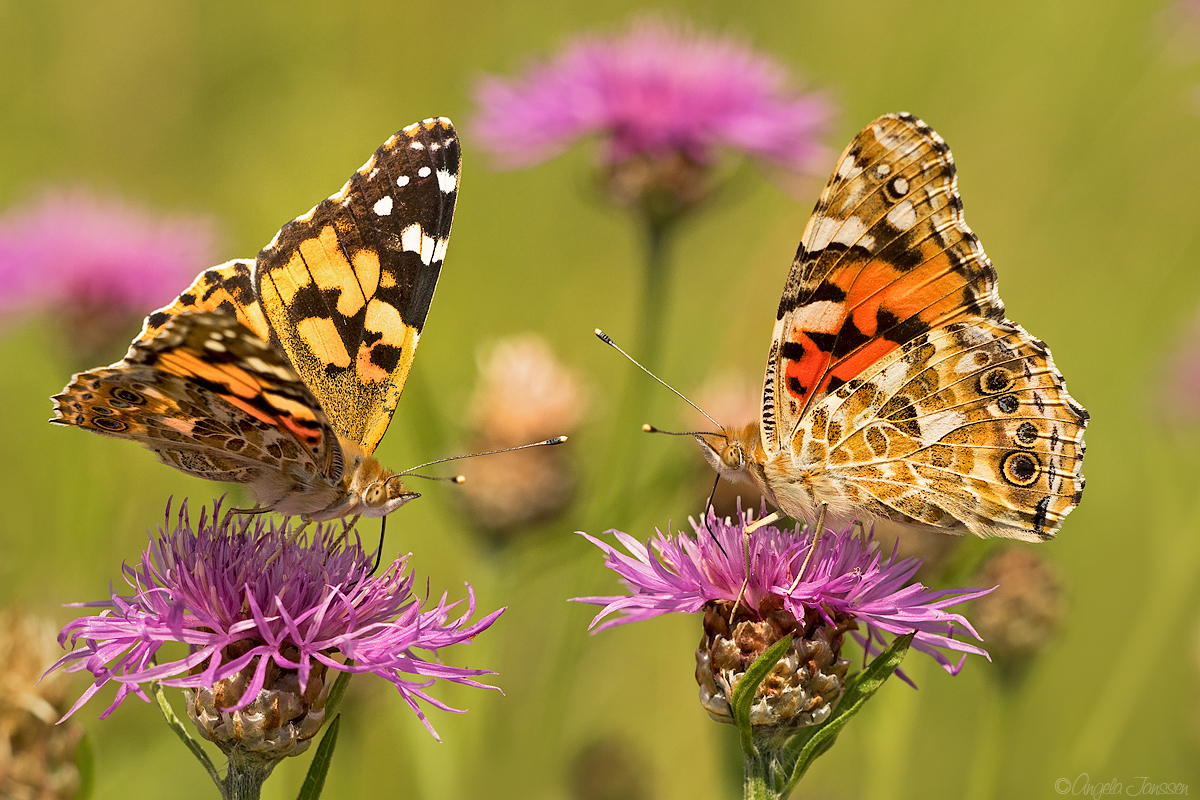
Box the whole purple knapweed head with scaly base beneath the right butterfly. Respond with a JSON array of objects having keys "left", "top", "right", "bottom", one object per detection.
[{"left": 576, "top": 511, "right": 990, "bottom": 728}]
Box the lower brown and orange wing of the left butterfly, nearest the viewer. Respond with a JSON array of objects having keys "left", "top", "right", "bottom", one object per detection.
[{"left": 52, "top": 311, "right": 343, "bottom": 512}]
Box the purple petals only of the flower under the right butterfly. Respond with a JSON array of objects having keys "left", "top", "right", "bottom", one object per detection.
[{"left": 575, "top": 511, "right": 991, "bottom": 674}]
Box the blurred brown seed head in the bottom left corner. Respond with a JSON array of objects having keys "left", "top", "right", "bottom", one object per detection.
[{"left": 0, "top": 609, "right": 83, "bottom": 800}]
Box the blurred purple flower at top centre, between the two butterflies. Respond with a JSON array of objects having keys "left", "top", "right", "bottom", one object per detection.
[{"left": 475, "top": 19, "right": 832, "bottom": 172}]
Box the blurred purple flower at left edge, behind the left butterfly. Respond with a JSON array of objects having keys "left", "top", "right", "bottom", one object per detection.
[{"left": 0, "top": 190, "right": 215, "bottom": 317}]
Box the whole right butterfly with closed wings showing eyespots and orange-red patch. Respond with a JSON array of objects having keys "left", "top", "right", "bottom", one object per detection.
[{"left": 696, "top": 114, "right": 1088, "bottom": 541}]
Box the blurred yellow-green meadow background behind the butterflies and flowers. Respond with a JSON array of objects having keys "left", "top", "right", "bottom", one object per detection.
[{"left": 0, "top": 0, "right": 1200, "bottom": 799}]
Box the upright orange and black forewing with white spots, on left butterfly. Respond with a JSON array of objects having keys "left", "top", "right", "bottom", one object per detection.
[{"left": 254, "top": 119, "right": 460, "bottom": 453}]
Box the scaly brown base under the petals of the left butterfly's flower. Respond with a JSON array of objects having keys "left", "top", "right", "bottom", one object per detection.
[{"left": 184, "top": 640, "right": 330, "bottom": 763}]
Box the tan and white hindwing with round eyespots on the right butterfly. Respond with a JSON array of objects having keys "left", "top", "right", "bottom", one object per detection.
[{"left": 792, "top": 320, "right": 1087, "bottom": 541}]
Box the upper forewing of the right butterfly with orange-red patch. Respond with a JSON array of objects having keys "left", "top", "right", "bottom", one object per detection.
[{"left": 762, "top": 114, "right": 1004, "bottom": 453}]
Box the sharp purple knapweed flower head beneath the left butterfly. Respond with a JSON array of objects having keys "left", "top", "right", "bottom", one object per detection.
[{"left": 55, "top": 501, "right": 503, "bottom": 754}]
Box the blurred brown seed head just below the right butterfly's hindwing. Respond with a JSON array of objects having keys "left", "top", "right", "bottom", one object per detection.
[{"left": 972, "top": 547, "right": 1063, "bottom": 666}]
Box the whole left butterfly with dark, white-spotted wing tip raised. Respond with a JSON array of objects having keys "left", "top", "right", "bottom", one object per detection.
[{"left": 50, "top": 119, "right": 461, "bottom": 521}]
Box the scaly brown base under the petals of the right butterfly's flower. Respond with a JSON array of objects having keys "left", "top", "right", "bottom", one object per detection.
[{"left": 696, "top": 595, "right": 854, "bottom": 729}]
